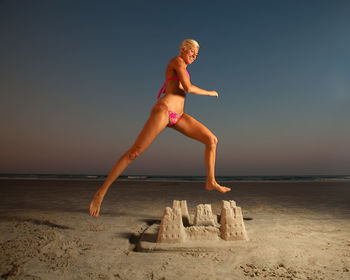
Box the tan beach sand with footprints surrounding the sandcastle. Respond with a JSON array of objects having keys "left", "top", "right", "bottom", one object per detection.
[{"left": 0, "top": 180, "right": 350, "bottom": 280}]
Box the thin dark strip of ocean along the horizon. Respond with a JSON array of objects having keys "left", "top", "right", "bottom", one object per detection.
[{"left": 0, "top": 174, "right": 350, "bottom": 182}]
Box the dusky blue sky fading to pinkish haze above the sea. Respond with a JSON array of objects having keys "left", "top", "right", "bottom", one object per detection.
[{"left": 0, "top": 0, "right": 350, "bottom": 176}]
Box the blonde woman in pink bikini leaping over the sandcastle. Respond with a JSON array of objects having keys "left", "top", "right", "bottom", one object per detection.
[{"left": 90, "top": 39, "right": 231, "bottom": 217}]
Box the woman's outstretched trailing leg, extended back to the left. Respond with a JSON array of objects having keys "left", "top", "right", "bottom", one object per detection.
[{"left": 90, "top": 104, "right": 168, "bottom": 217}]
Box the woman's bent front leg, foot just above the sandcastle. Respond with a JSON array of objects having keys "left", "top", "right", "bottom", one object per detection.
[{"left": 173, "top": 114, "right": 231, "bottom": 193}]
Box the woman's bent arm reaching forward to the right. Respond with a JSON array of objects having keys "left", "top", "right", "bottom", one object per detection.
[{"left": 174, "top": 57, "right": 218, "bottom": 97}]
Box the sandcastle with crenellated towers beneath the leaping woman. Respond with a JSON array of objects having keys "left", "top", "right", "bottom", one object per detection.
[{"left": 140, "top": 200, "right": 248, "bottom": 251}]
